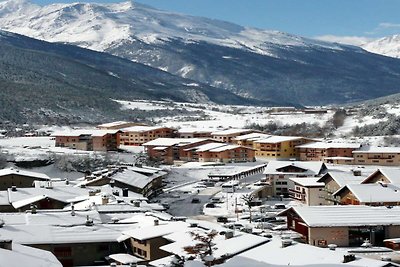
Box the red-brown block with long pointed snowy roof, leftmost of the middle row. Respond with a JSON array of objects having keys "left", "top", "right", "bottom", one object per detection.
[{"left": 143, "top": 138, "right": 215, "bottom": 164}]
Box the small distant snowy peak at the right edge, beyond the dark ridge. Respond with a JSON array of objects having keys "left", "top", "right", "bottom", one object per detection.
[{"left": 361, "top": 34, "right": 400, "bottom": 58}]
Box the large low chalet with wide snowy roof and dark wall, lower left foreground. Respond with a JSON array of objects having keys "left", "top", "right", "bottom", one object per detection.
[{"left": 1, "top": 210, "right": 130, "bottom": 267}]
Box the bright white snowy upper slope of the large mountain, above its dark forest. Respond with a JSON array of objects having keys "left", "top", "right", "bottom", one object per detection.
[{"left": 0, "top": 0, "right": 341, "bottom": 55}]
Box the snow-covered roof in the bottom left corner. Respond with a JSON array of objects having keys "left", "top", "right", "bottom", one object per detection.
[{"left": 0, "top": 243, "right": 62, "bottom": 267}]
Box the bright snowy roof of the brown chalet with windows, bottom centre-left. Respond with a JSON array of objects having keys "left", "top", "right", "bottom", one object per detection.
[{"left": 123, "top": 221, "right": 189, "bottom": 240}]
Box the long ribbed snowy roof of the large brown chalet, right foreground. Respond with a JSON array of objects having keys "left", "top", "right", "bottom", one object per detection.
[{"left": 282, "top": 205, "right": 400, "bottom": 227}]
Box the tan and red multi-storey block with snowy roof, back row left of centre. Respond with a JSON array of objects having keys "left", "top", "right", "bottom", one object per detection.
[{"left": 119, "top": 126, "right": 176, "bottom": 146}]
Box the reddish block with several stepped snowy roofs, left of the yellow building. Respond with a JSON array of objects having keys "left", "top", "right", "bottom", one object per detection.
[{"left": 185, "top": 142, "right": 255, "bottom": 163}]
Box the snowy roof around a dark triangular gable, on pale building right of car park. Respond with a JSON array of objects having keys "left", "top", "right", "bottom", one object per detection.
[{"left": 263, "top": 160, "right": 325, "bottom": 175}]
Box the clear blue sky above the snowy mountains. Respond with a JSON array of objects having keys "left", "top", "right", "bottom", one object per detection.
[{"left": 31, "top": 0, "right": 400, "bottom": 43}]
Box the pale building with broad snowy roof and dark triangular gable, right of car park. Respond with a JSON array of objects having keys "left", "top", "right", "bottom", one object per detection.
[{"left": 264, "top": 161, "right": 327, "bottom": 197}]
